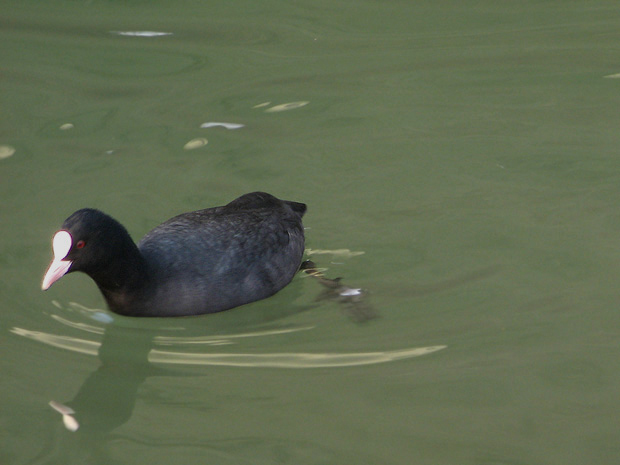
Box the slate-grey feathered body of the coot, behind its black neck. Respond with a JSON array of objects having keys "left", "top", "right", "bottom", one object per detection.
[{"left": 138, "top": 193, "right": 306, "bottom": 314}]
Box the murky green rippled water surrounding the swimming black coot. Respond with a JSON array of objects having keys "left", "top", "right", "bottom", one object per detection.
[{"left": 0, "top": 0, "right": 620, "bottom": 465}]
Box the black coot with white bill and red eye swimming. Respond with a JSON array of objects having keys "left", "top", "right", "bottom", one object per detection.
[{"left": 41, "top": 192, "right": 306, "bottom": 316}]
